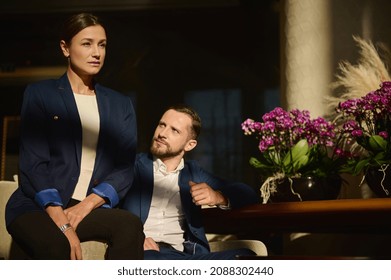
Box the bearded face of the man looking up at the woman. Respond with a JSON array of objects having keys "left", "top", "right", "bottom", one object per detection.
[{"left": 151, "top": 110, "right": 196, "bottom": 159}]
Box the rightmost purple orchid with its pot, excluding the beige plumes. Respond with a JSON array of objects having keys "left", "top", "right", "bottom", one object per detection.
[{"left": 337, "top": 82, "right": 391, "bottom": 196}]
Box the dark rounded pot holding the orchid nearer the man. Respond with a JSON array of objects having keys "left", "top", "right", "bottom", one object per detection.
[{"left": 269, "top": 177, "right": 342, "bottom": 202}]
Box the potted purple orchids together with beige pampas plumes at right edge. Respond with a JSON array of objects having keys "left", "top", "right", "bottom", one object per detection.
[{"left": 327, "top": 36, "right": 391, "bottom": 196}]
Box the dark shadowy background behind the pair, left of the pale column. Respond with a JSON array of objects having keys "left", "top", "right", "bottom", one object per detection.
[{"left": 0, "top": 0, "right": 280, "bottom": 183}]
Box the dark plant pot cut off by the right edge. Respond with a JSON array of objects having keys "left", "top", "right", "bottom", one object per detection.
[{"left": 365, "top": 166, "right": 391, "bottom": 197}]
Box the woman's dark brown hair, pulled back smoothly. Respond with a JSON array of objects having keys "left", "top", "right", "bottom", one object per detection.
[{"left": 60, "top": 13, "right": 105, "bottom": 45}]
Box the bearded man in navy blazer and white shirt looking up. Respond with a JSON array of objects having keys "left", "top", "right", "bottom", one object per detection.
[{"left": 122, "top": 106, "right": 259, "bottom": 259}]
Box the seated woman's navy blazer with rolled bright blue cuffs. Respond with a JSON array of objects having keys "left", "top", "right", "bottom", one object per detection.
[{"left": 6, "top": 74, "right": 137, "bottom": 228}]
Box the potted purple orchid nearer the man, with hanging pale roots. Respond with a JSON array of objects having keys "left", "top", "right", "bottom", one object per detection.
[{"left": 242, "top": 107, "right": 342, "bottom": 203}]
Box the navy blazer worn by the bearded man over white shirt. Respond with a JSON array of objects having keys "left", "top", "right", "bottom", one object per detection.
[{"left": 121, "top": 153, "right": 259, "bottom": 250}]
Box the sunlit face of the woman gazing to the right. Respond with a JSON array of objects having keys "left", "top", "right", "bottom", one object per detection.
[{"left": 60, "top": 25, "right": 107, "bottom": 76}]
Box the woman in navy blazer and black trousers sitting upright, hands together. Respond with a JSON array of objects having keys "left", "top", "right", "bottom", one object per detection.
[{"left": 6, "top": 13, "right": 144, "bottom": 259}]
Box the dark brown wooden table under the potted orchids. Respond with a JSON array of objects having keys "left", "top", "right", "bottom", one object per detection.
[{"left": 202, "top": 198, "right": 391, "bottom": 235}]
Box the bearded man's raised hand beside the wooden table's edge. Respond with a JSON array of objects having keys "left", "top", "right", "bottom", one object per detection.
[{"left": 189, "top": 181, "right": 228, "bottom": 206}]
